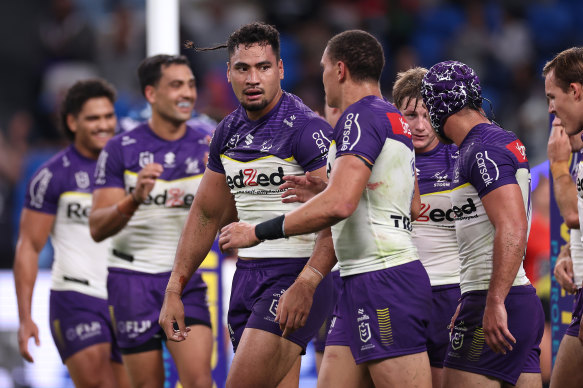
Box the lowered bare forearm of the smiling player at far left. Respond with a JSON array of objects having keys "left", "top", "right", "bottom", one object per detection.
[{"left": 13, "top": 240, "right": 39, "bottom": 322}]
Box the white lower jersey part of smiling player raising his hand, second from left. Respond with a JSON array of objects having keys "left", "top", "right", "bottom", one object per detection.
[{"left": 109, "top": 170, "right": 202, "bottom": 273}]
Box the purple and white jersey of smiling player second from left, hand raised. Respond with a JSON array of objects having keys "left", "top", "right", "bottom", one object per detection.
[{"left": 95, "top": 123, "right": 209, "bottom": 273}]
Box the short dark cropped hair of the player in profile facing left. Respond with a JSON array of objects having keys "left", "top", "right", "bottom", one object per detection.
[{"left": 326, "top": 30, "right": 385, "bottom": 82}]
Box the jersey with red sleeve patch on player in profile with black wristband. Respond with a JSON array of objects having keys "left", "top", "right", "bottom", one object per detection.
[{"left": 328, "top": 96, "right": 418, "bottom": 276}]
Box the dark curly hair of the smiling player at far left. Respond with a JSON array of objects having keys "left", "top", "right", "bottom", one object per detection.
[{"left": 60, "top": 78, "right": 117, "bottom": 141}]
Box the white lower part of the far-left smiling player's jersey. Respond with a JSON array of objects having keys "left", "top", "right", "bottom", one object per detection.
[{"left": 51, "top": 191, "right": 110, "bottom": 299}]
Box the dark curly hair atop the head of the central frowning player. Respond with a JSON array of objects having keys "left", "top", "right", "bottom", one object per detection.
[{"left": 227, "top": 22, "right": 280, "bottom": 61}]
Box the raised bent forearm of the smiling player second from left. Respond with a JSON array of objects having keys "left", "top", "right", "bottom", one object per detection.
[{"left": 89, "top": 194, "right": 140, "bottom": 242}]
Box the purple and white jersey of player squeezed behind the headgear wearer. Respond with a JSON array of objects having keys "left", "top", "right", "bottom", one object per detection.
[{"left": 413, "top": 143, "right": 460, "bottom": 286}]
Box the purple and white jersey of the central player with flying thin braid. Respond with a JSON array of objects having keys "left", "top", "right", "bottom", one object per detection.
[{"left": 208, "top": 92, "right": 332, "bottom": 258}]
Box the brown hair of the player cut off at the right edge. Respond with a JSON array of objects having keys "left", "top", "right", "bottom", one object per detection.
[{"left": 543, "top": 47, "right": 583, "bottom": 92}]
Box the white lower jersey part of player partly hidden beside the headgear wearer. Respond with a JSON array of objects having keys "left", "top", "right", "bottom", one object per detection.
[{"left": 412, "top": 190, "right": 460, "bottom": 286}]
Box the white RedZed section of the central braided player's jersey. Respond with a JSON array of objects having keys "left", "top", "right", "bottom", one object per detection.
[{"left": 221, "top": 155, "right": 316, "bottom": 258}]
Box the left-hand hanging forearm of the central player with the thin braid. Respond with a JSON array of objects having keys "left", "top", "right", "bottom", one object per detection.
[{"left": 166, "top": 202, "right": 222, "bottom": 294}]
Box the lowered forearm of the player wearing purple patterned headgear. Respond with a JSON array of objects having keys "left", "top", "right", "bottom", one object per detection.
[{"left": 487, "top": 223, "right": 527, "bottom": 303}]
